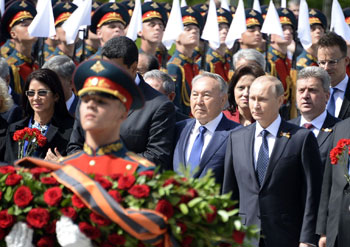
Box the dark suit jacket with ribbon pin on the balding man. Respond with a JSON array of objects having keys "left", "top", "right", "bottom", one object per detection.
[{"left": 223, "top": 120, "right": 321, "bottom": 247}]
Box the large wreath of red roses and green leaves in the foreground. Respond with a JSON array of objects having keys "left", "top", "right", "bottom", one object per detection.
[{"left": 0, "top": 163, "right": 257, "bottom": 247}]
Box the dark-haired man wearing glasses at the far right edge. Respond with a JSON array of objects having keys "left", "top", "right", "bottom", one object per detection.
[{"left": 317, "top": 32, "right": 350, "bottom": 119}]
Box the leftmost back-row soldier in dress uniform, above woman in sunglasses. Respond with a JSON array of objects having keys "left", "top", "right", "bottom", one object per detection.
[{"left": 1, "top": 0, "right": 38, "bottom": 94}]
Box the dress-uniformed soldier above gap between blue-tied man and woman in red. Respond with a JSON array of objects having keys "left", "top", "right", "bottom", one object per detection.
[{"left": 197, "top": 8, "right": 232, "bottom": 82}]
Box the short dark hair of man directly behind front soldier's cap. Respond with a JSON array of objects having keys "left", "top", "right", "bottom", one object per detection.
[{"left": 101, "top": 36, "right": 139, "bottom": 68}]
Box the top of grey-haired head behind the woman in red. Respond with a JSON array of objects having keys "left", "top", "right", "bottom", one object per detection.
[{"left": 233, "top": 49, "right": 266, "bottom": 70}]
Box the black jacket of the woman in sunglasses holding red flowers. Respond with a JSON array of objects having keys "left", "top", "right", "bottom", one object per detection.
[{"left": 4, "top": 117, "right": 74, "bottom": 164}]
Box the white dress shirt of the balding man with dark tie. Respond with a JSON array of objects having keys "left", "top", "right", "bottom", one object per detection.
[{"left": 254, "top": 115, "right": 282, "bottom": 169}]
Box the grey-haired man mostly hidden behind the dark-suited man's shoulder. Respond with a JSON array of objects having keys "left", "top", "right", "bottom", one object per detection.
[{"left": 143, "top": 69, "right": 188, "bottom": 122}]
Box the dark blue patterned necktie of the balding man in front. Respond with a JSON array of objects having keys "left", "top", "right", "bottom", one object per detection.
[{"left": 256, "top": 130, "right": 269, "bottom": 186}]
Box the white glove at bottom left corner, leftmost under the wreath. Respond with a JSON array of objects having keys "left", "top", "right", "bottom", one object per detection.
[{"left": 5, "top": 222, "right": 34, "bottom": 247}]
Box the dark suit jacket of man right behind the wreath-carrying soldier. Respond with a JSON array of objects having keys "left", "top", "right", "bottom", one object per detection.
[{"left": 67, "top": 76, "right": 175, "bottom": 169}]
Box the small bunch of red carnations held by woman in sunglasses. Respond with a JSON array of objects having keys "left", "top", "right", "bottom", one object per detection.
[{"left": 13, "top": 127, "right": 47, "bottom": 159}]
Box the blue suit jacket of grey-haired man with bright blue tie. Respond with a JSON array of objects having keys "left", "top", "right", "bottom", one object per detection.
[{"left": 173, "top": 115, "right": 240, "bottom": 184}]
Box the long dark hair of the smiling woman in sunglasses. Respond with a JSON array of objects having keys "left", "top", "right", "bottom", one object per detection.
[{"left": 22, "top": 69, "right": 72, "bottom": 119}]
